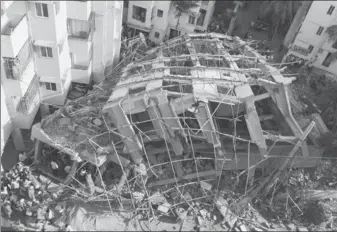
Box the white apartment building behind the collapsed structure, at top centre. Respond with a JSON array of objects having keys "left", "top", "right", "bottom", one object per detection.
[{"left": 124, "top": 1, "right": 215, "bottom": 44}]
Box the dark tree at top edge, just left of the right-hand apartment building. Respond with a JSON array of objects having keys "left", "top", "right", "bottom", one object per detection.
[{"left": 260, "top": 1, "right": 300, "bottom": 41}]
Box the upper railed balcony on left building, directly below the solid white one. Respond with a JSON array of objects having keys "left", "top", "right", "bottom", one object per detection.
[{"left": 3, "top": 39, "right": 33, "bottom": 80}]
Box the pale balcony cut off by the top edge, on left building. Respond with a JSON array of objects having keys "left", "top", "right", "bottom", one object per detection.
[{"left": 67, "top": 1, "right": 91, "bottom": 20}]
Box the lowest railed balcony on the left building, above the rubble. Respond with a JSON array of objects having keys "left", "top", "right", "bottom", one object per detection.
[{"left": 16, "top": 75, "right": 40, "bottom": 115}]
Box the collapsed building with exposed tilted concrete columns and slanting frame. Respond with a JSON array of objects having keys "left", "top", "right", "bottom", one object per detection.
[{"left": 32, "top": 33, "right": 324, "bottom": 210}]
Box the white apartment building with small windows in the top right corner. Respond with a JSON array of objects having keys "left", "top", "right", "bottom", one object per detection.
[{"left": 283, "top": 1, "right": 337, "bottom": 78}]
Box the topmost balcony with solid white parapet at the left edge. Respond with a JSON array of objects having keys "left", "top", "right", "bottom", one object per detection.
[{"left": 1, "top": 15, "right": 29, "bottom": 58}]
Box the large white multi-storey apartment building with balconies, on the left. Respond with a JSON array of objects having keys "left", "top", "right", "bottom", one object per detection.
[{"left": 1, "top": 1, "right": 123, "bottom": 156}]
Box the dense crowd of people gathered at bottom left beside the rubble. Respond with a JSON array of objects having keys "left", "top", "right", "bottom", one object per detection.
[{"left": 1, "top": 162, "right": 71, "bottom": 231}]
